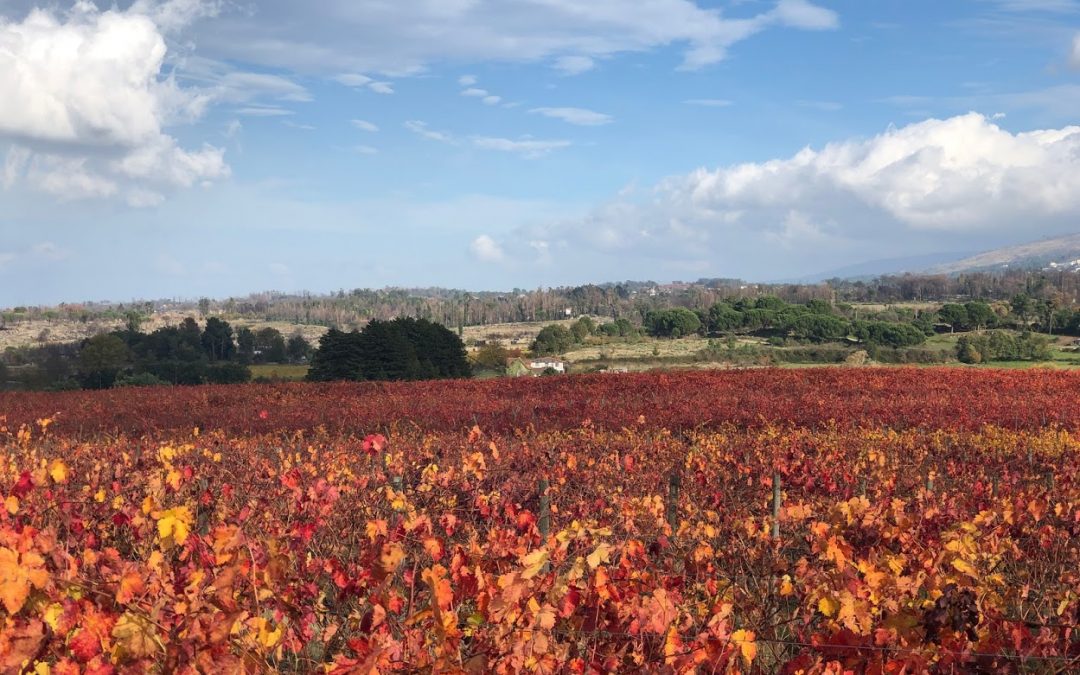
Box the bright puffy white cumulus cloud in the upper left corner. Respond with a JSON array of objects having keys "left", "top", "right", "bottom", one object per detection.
[{"left": 0, "top": 0, "right": 229, "bottom": 205}]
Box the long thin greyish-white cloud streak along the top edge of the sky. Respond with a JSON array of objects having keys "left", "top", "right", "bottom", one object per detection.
[{"left": 172, "top": 0, "right": 838, "bottom": 73}]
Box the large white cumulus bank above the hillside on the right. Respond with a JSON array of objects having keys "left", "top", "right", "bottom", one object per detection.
[{"left": 488, "top": 113, "right": 1080, "bottom": 272}]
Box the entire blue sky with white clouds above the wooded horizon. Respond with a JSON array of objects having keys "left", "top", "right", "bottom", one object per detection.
[{"left": 0, "top": 0, "right": 1080, "bottom": 306}]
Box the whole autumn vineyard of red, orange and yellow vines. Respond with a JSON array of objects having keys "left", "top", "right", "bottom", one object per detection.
[{"left": 0, "top": 368, "right": 1080, "bottom": 674}]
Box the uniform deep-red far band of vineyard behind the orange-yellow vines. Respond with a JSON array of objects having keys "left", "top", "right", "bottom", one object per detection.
[{"left": 0, "top": 368, "right": 1080, "bottom": 434}]
